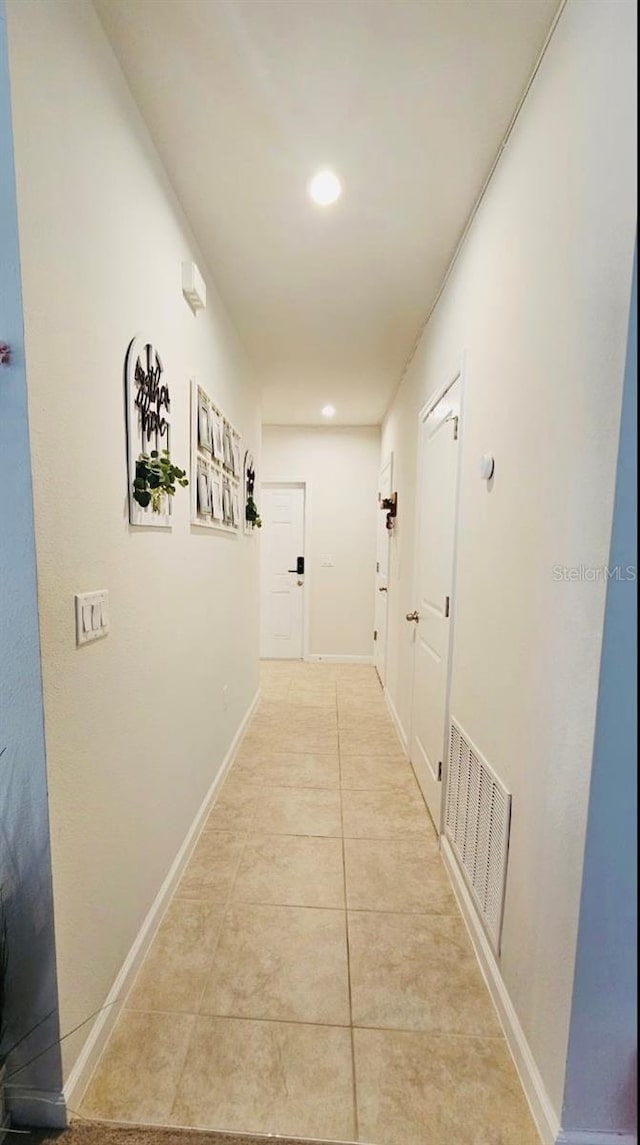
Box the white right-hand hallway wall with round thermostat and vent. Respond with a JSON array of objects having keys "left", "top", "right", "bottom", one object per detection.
[{"left": 382, "top": 0, "right": 635, "bottom": 1119}]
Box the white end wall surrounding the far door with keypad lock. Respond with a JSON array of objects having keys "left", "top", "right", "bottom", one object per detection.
[{"left": 260, "top": 426, "right": 380, "bottom": 657}]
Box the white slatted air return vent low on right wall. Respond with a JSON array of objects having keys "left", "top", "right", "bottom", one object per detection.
[{"left": 444, "top": 720, "right": 511, "bottom": 954}]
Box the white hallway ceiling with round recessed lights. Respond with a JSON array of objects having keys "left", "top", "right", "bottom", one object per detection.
[{"left": 95, "top": 0, "right": 558, "bottom": 425}]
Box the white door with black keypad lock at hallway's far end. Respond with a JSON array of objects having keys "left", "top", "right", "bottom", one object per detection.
[{"left": 260, "top": 485, "right": 305, "bottom": 660}]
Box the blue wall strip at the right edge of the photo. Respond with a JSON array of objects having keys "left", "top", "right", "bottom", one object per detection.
[{"left": 562, "top": 246, "right": 638, "bottom": 1132}]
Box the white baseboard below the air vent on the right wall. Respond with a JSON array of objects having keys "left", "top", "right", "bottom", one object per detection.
[{"left": 440, "top": 835, "right": 561, "bottom": 1145}]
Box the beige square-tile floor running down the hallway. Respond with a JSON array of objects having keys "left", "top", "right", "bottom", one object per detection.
[{"left": 80, "top": 662, "right": 538, "bottom": 1145}]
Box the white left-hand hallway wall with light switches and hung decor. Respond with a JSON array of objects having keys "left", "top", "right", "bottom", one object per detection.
[{"left": 8, "top": 0, "right": 259, "bottom": 1074}]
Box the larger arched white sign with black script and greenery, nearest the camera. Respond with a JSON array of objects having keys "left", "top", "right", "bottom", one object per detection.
[{"left": 125, "top": 338, "right": 189, "bottom": 529}]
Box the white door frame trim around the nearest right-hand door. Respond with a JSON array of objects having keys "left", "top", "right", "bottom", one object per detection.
[{"left": 406, "top": 350, "right": 467, "bottom": 836}]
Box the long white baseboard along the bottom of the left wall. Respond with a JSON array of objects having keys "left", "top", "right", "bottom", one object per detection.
[{"left": 60, "top": 689, "right": 260, "bottom": 1124}]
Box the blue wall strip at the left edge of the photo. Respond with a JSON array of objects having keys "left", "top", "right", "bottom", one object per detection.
[{"left": 0, "top": 0, "right": 62, "bottom": 1134}]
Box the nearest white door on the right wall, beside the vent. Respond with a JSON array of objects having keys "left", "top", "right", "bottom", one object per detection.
[{"left": 406, "top": 378, "right": 461, "bottom": 831}]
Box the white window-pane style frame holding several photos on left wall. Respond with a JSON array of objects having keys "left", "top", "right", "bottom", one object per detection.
[{"left": 191, "top": 380, "right": 244, "bottom": 534}]
